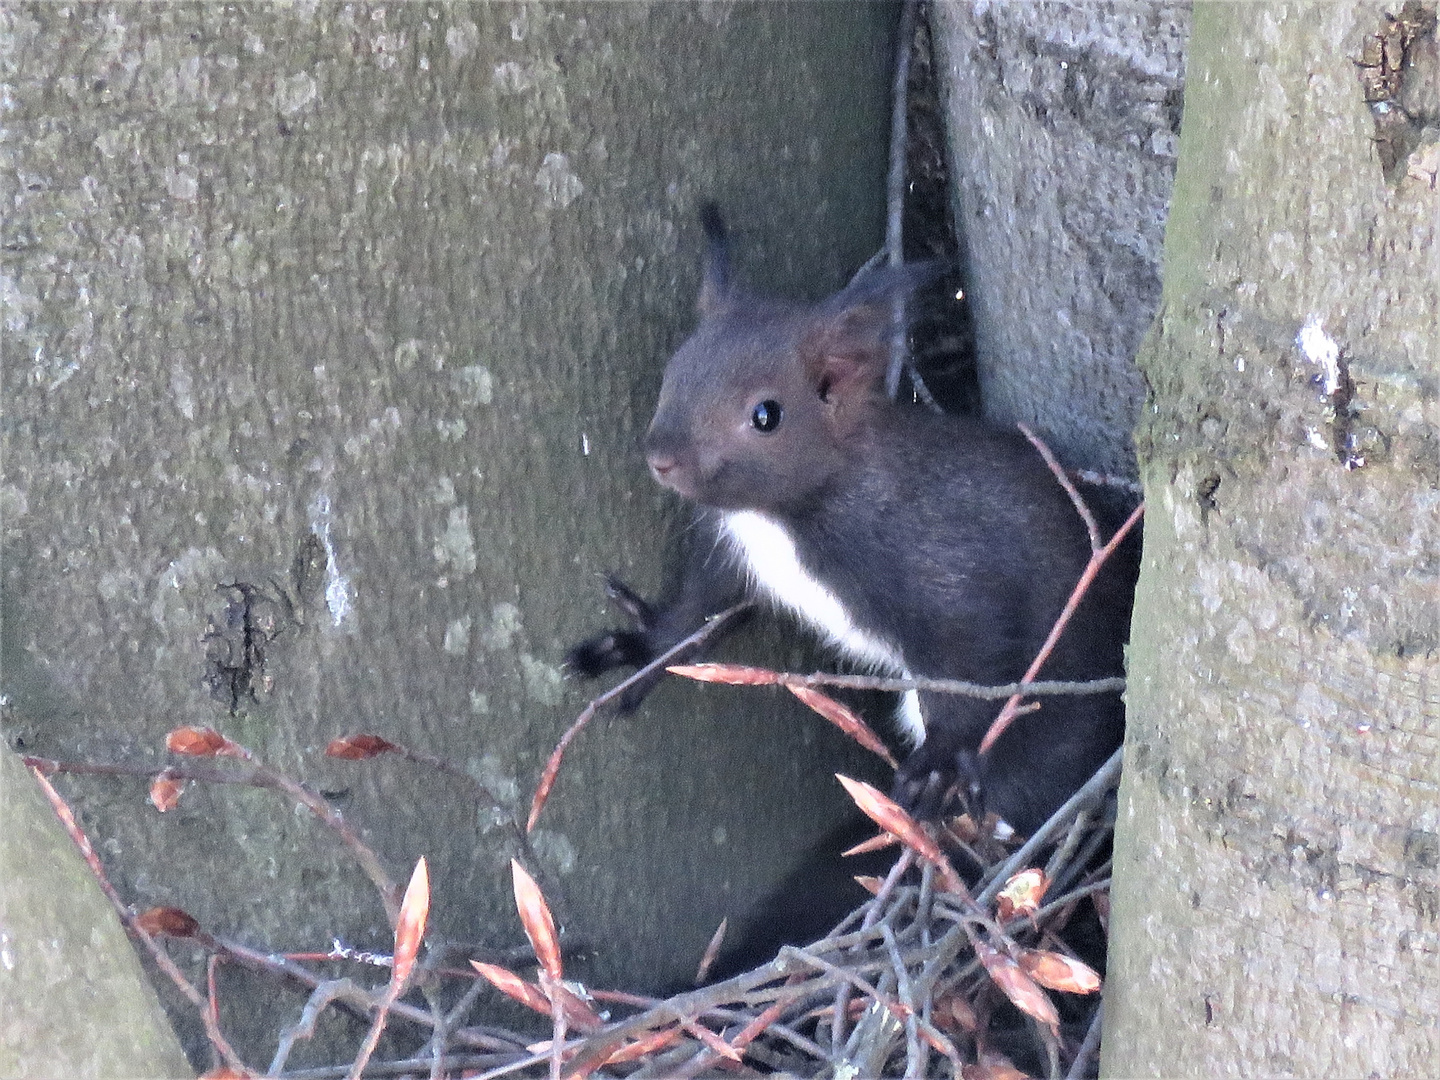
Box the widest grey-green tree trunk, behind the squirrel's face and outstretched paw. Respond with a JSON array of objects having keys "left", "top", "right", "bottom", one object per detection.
[{"left": 0, "top": 3, "right": 894, "bottom": 1064}]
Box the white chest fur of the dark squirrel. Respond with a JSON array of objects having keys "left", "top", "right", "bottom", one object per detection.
[{"left": 720, "top": 510, "right": 924, "bottom": 744}]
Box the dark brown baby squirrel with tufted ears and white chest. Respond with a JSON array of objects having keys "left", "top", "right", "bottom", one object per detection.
[{"left": 566, "top": 206, "right": 1136, "bottom": 832}]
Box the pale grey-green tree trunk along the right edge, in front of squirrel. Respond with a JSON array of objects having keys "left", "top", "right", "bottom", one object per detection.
[{"left": 1103, "top": 3, "right": 1440, "bottom": 1077}]
